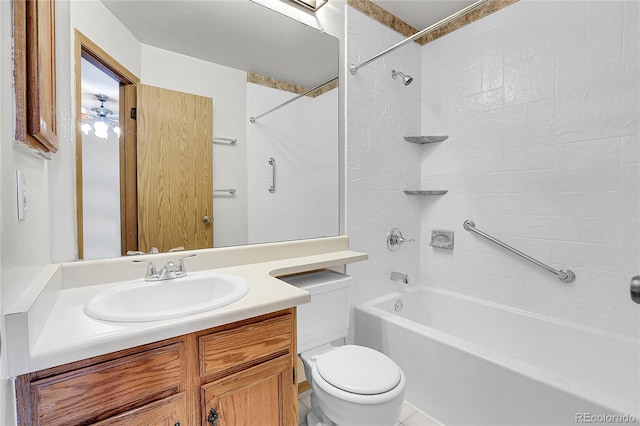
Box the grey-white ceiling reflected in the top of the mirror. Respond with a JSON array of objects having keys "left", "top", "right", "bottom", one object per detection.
[{"left": 102, "top": 0, "right": 338, "bottom": 87}]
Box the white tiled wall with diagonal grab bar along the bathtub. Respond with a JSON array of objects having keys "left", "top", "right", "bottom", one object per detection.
[{"left": 422, "top": 0, "right": 640, "bottom": 339}]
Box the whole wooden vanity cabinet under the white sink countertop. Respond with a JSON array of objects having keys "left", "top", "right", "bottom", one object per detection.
[{"left": 16, "top": 308, "right": 298, "bottom": 426}]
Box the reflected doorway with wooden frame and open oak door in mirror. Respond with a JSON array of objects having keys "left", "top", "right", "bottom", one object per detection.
[{"left": 76, "top": 33, "right": 213, "bottom": 259}]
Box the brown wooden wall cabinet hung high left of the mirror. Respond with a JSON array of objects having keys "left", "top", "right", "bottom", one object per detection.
[{"left": 13, "top": 0, "right": 58, "bottom": 152}]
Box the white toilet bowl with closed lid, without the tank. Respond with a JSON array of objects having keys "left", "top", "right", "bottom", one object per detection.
[{"left": 300, "top": 345, "right": 406, "bottom": 426}]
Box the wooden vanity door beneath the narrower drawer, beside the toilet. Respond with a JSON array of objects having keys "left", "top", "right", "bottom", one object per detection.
[{"left": 202, "top": 356, "right": 298, "bottom": 426}]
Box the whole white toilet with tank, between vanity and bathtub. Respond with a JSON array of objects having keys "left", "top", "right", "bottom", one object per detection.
[{"left": 283, "top": 271, "right": 405, "bottom": 426}]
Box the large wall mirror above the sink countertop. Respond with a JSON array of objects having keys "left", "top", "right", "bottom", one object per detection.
[{"left": 70, "top": 0, "right": 339, "bottom": 259}]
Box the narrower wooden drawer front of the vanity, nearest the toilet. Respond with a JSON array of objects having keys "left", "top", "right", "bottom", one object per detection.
[{"left": 198, "top": 314, "right": 293, "bottom": 376}]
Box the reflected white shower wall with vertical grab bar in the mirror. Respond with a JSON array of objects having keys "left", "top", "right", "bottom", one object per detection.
[{"left": 247, "top": 83, "right": 338, "bottom": 243}]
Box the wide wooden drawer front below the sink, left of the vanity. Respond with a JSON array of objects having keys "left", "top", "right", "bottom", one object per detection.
[{"left": 30, "top": 343, "right": 186, "bottom": 425}]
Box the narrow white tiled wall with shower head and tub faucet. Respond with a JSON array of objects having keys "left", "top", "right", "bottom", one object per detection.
[{"left": 346, "top": 6, "right": 423, "bottom": 318}]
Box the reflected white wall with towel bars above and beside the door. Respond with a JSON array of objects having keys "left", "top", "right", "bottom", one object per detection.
[{"left": 141, "top": 45, "right": 248, "bottom": 247}]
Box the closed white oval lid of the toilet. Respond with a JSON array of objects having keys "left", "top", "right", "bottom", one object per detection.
[{"left": 316, "top": 345, "right": 401, "bottom": 395}]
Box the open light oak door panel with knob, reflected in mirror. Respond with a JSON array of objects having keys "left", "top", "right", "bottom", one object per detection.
[{"left": 136, "top": 84, "right": 213, "bottom": 252}]
